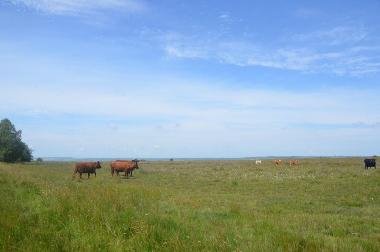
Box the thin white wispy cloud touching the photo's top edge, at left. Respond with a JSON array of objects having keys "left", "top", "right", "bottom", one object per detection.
[{"left": 8, "top": 0, "right": 145, "bottom": 16}]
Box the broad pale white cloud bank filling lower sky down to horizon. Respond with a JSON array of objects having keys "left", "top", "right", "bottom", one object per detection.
[{"left": 0, "top": 78, "right": 380, "bottom": 157}]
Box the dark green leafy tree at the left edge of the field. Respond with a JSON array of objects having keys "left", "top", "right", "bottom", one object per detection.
[{"left": 0, "top": 119, "right": 33, "bottom": 163}]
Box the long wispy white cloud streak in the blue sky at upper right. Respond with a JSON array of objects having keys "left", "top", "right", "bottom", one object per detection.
[{"left": 164, "top": 26, "right": 380, "bottom": 75}]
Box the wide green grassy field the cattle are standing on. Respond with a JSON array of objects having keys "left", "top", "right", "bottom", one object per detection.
[{"left": 0, "top": 158, "right": 380, "bottom": 251}]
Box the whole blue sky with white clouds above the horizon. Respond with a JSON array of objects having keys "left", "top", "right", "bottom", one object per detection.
[{"left": 0, "top": 0, "right": 380, "bottom": 158}]
